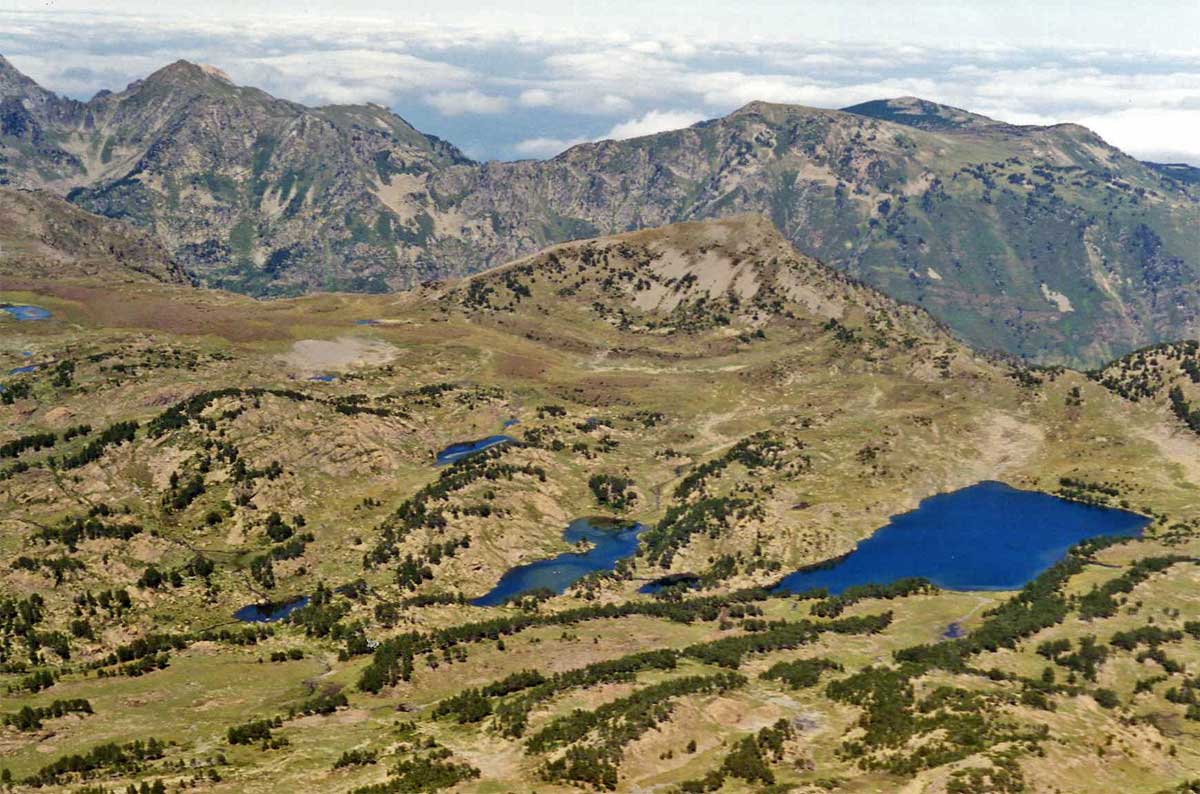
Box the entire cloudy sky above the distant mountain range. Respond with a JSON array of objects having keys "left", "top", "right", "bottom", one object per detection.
[{"left": 0, "top": 0, "right": 1200, "bottom": 166}]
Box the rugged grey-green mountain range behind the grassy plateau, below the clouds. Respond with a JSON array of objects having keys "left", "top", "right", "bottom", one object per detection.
[{"left": 0, "top": 58, "right": 1200, "bottom": 365}]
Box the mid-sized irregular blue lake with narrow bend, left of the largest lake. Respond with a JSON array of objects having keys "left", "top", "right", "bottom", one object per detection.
[{"left": 472, "top": 518, "right": 646, "bottom": 607}]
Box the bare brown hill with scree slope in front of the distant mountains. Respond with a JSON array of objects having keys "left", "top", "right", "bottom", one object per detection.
[{"left": 436, "top": 213, "right": 952, "bottom": 347}]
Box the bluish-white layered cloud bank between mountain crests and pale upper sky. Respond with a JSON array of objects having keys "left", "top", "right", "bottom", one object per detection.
[{"left": 0, "top": 12, "right": 1200, "bottom": 166}]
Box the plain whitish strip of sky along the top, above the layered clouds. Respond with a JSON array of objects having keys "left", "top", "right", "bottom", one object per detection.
[{"left": 5, "top": 0, "right": 1200, "bottom": 49}]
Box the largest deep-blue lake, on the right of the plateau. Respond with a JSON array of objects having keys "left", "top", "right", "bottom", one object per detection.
[{"left": 776, "top": 482, "right": 1150, "bottom": 594}]
